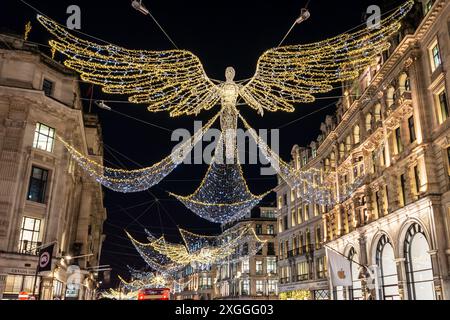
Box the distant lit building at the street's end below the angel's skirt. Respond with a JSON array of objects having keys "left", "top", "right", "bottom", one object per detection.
[{"left": 214, "top": 207, "right": 278, "bottom": 300}]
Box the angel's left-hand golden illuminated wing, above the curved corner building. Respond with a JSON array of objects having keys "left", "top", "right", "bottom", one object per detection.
[{"left": 38, "top": 16, "right": 219, "bottom": 116}]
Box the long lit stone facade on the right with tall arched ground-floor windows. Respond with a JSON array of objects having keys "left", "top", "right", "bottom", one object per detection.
[{"left": 277, "top": 0, "right": 450, "bottom": 300}]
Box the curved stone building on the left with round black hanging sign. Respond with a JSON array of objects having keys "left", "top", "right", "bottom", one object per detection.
[{"left": 0, "top": 35, "right": 106, "bottom": 299}]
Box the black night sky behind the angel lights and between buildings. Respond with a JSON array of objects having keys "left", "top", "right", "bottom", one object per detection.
[{"left": 0, "top": 0, "right": 402, "bottom": 288}]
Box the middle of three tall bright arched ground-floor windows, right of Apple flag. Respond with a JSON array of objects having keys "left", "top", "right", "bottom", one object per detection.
[{"left": 376, "top": 235, "right": 400, "bottom": 300}]
